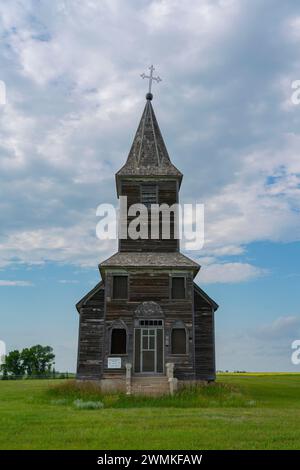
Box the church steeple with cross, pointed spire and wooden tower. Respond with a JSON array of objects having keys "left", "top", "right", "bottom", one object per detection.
[{"left": 116, "top": 66, "right": 182, "bottom": 253}]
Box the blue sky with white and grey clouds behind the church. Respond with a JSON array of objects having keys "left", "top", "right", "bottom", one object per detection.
[{"left": 0, "top": 0, "right": 300, "bottom": 371}]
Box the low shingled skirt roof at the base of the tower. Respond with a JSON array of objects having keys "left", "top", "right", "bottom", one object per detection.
[{"left": 99, "top": 252, "right": 200, "bottom": 275}]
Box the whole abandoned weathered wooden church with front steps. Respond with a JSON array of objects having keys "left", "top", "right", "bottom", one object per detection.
[{"left": 76, "top": 82, "right": 218, "bottom": 394}]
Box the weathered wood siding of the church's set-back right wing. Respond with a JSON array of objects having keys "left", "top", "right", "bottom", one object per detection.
[{"left": 194, "top": 290, "right": 216, "bottom": 380}]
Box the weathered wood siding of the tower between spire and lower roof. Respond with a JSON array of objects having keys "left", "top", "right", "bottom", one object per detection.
[{"left": 119, "top": 180, "right": 179, "bottom": 252}]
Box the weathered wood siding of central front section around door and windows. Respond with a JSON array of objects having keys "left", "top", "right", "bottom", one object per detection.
[{"left": 104, "top": 269, "right": 194, "bottom": 380}]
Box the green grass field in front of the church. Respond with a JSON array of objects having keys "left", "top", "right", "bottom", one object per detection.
[{"left": 0, "top": 374, "right": 300, "bottom": 450}]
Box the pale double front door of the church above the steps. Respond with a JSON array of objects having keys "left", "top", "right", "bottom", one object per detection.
[{"left": 134, "top": 320, "right": 164, "bottom": 374}]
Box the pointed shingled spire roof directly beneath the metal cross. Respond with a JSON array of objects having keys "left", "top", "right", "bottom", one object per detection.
[{"left": 116, "top": 99, "right": 182, "bottom": 195}]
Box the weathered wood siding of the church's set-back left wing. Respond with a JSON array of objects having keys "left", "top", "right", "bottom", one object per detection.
[{"left": 77, "top": 287, "right": 105, "bottom": 380}]
